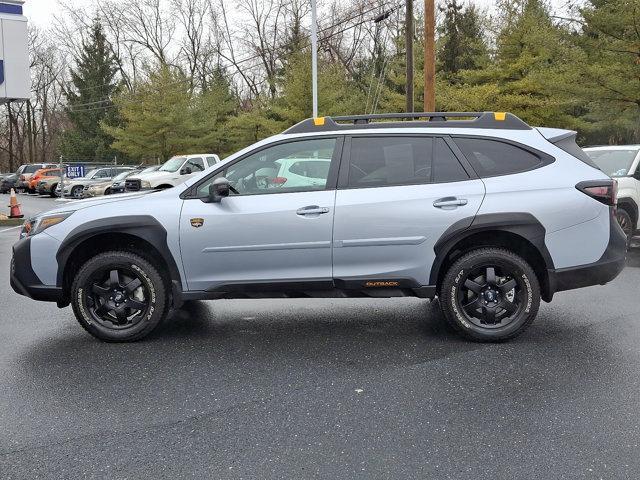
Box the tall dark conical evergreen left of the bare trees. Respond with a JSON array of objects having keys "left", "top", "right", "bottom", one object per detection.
[{"left": 59, "top": 20, "right": 118, "bottom": 161}]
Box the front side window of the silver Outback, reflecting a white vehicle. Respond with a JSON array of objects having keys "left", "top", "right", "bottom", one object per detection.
[{"left": 198, "top": 138, "right": 336, "bottom": 196}]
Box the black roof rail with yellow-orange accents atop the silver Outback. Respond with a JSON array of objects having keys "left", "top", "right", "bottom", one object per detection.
[{"left": 283, "top": 112, "right": 531, "bottom": 134}]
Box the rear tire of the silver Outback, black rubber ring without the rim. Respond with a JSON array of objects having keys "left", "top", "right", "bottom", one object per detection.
[{"left": 441, "top": 250, "right": 540, "bottom": 341}]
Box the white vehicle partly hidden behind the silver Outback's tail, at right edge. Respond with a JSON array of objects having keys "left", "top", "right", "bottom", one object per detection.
[{"left": 584, "top": 145, "right": 640, "bottom": 239}]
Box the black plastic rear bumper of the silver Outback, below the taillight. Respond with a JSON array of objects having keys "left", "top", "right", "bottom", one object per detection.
[{"left": 548, "top": 216, "right": 627, "bottom": 297}]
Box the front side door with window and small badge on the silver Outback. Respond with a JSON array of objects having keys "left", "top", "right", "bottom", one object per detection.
[{"left": 180, "top": 138, "right": 338, "bottom": 290}]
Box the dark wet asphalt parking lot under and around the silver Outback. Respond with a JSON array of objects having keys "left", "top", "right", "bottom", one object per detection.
[{"left": 0, "top": 196, "right": 640, "bottom": 479}]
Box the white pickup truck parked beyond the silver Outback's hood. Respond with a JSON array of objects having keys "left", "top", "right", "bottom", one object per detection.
[{"left": 125, "top": 153, "right": 220, "bottom": 192}]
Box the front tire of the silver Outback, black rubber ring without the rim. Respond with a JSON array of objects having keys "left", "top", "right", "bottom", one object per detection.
[{"left": 71, "top": 252, "right": 167, "bottom": 342}]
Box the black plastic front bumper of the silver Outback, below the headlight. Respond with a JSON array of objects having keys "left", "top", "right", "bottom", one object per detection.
[{"left": 9, "top": 237, "right": 64, "bottom": 303}]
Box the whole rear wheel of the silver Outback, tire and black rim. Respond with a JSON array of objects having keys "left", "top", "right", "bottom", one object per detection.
[{"left": 439, "top": 247, "right": 540, "bottom": 342}]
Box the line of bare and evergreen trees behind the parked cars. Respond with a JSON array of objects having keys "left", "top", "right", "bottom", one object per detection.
[{"left": 0, "top": 0, "right": 640, "bottom": 171}]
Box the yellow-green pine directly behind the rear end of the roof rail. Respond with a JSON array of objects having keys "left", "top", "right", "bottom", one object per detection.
[{"left": 437, "top": 0, "right": 577, "bottom": 127}]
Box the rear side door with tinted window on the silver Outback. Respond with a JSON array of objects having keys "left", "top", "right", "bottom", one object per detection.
[{"left": 333, "top": 135, "right": 485, "bottom": 287}]
